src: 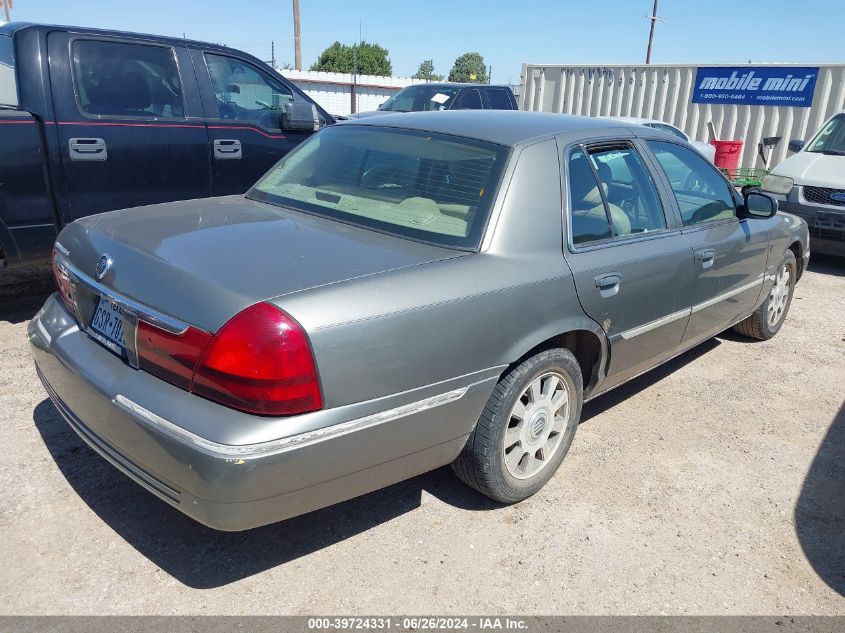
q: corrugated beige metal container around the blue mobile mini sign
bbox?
[520,64,845,167]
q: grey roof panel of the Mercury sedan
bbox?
[343,110,630,146]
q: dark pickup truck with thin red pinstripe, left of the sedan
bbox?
[0,23,334,265]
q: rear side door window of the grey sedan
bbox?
[569,143,666,244]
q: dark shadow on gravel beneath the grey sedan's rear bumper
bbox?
[33,400,501,589]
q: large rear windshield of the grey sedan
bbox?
[248,124,508,249]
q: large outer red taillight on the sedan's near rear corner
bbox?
[191,303,323,415]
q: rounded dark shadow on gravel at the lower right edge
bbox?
[795,403,845,596]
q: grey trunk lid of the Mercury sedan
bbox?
[59,196,465,332]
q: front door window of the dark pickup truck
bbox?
[205,53,293,130]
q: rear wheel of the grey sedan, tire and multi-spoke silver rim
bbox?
[452,349,584,503]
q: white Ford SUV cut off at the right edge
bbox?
[763,111,845,255]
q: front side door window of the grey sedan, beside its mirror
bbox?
[648,141,736,226]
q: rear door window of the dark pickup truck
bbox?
[72,40,184,118]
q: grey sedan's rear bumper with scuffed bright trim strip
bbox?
[28,295,499,531]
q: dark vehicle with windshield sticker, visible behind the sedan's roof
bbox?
[344,83,519,119]
